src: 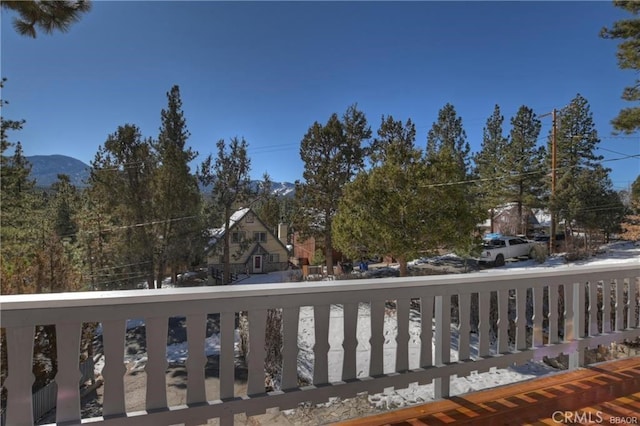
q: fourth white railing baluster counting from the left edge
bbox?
[144,317,168,411]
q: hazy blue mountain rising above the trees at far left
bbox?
[26,155,91,188]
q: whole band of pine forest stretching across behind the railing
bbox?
[0,79,638,294]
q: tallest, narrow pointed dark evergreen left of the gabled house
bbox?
[153,86,204,286]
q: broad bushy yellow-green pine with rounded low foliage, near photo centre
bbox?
[332,116,428,276]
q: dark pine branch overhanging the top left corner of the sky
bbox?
[0,0,91,38]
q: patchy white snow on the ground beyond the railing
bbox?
[96,243,640,409]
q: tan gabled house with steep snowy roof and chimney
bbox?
[207,208,289,275]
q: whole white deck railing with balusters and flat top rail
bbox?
[0,265,640,426]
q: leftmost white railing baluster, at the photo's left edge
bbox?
[4,326,34,426]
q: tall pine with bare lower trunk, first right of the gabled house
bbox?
[295,105,371,273]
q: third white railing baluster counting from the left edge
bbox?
[102,320,127,417]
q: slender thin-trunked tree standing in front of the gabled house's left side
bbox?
[198,137,255,284]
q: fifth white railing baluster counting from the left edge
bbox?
[185,314,207,404]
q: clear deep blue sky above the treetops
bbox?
[1,1,640,189]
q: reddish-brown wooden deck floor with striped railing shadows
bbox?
[341,356,640,426]
